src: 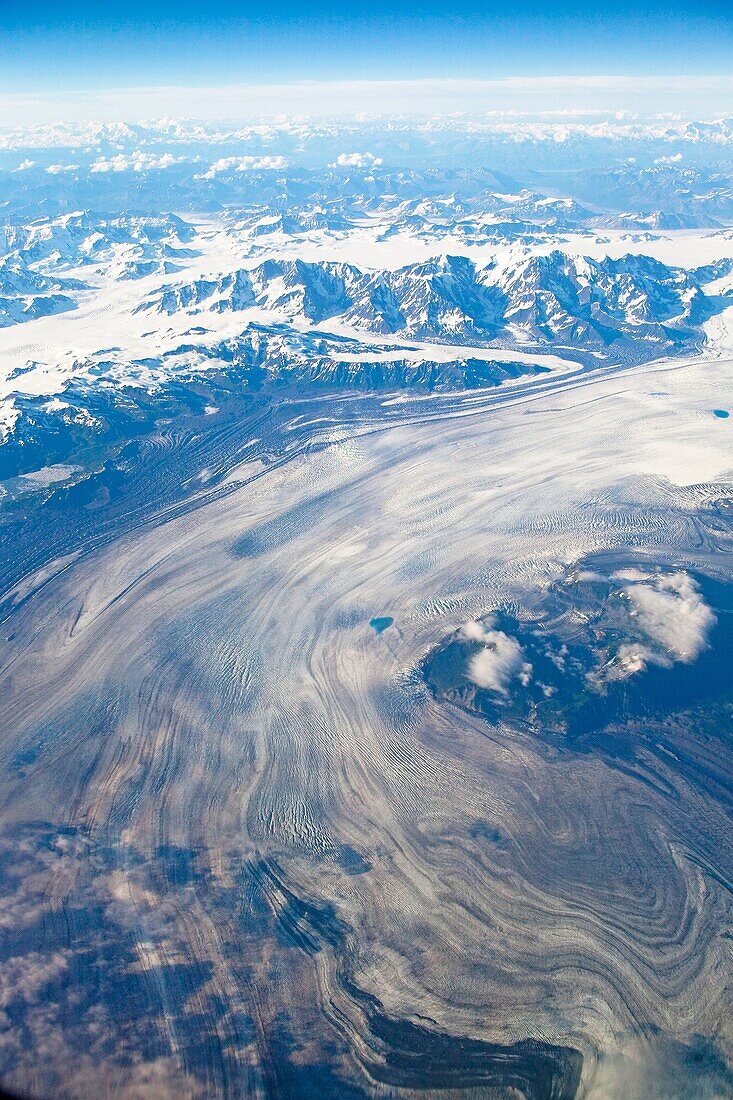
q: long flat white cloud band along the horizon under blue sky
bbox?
[0,75,733,127]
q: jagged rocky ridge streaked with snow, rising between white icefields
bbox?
[139,251,711,356]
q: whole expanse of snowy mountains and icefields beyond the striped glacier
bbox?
[0,144,733,493]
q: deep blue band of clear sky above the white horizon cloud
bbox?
[0,0,733,94]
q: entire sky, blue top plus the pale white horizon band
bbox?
[0,0,733,125]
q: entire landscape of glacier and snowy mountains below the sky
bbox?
[0,114,733,1100]
